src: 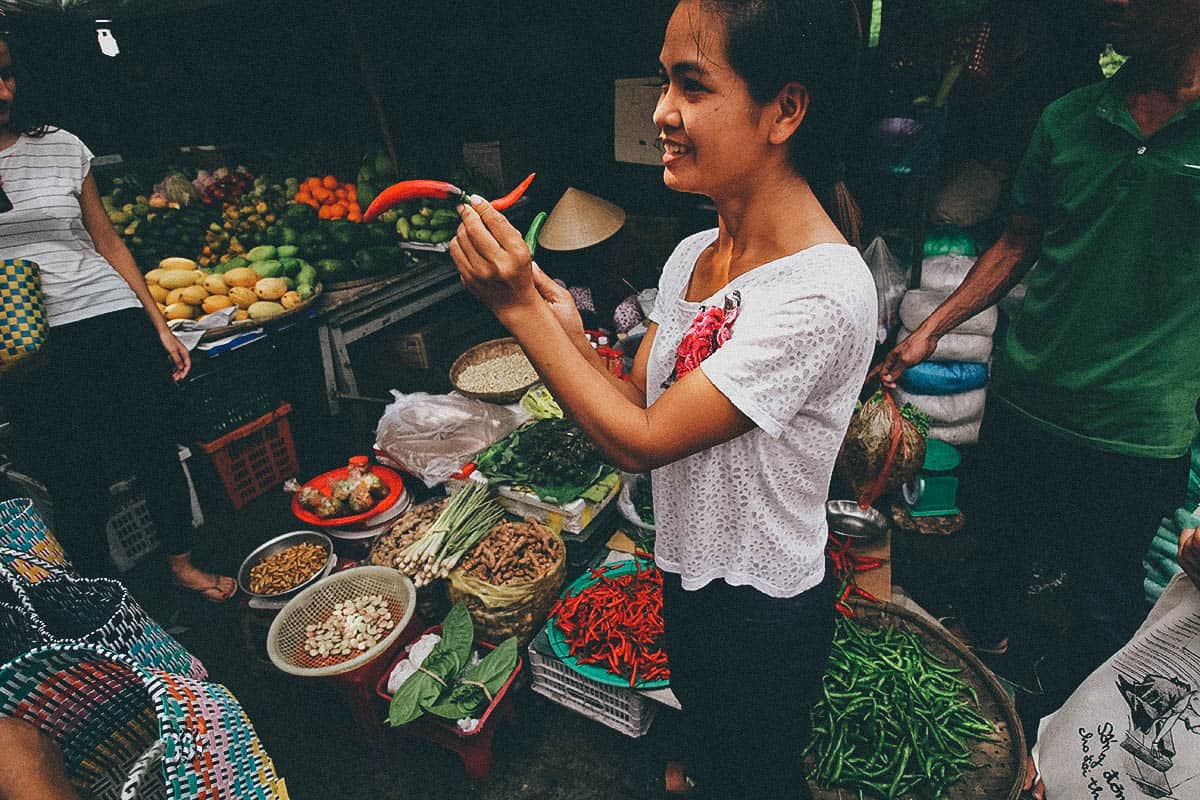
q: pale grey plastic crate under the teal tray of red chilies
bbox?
[527,648,659,738]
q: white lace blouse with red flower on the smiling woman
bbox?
[646,229,877,597]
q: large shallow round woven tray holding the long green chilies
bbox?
[810,600,1026,800]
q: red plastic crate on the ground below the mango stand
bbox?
[200,403,298,510]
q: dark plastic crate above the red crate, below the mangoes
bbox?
[182,365,278,441]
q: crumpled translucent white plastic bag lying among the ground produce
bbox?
[376,390,529,487]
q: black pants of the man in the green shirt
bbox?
[962,403,1189,708]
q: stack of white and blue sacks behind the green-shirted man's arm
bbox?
[896,225,998,445]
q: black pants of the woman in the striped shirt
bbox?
[0,308,191,575]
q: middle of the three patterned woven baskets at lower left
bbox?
[0,547,208,679]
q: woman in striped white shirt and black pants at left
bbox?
[0,38,236,602]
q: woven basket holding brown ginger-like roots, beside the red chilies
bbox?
[446,522,566,648]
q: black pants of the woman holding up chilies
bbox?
[662,572,834,800]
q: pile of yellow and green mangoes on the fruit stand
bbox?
[145,250,317,323]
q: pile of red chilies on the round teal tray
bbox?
[550,560,670,687]
